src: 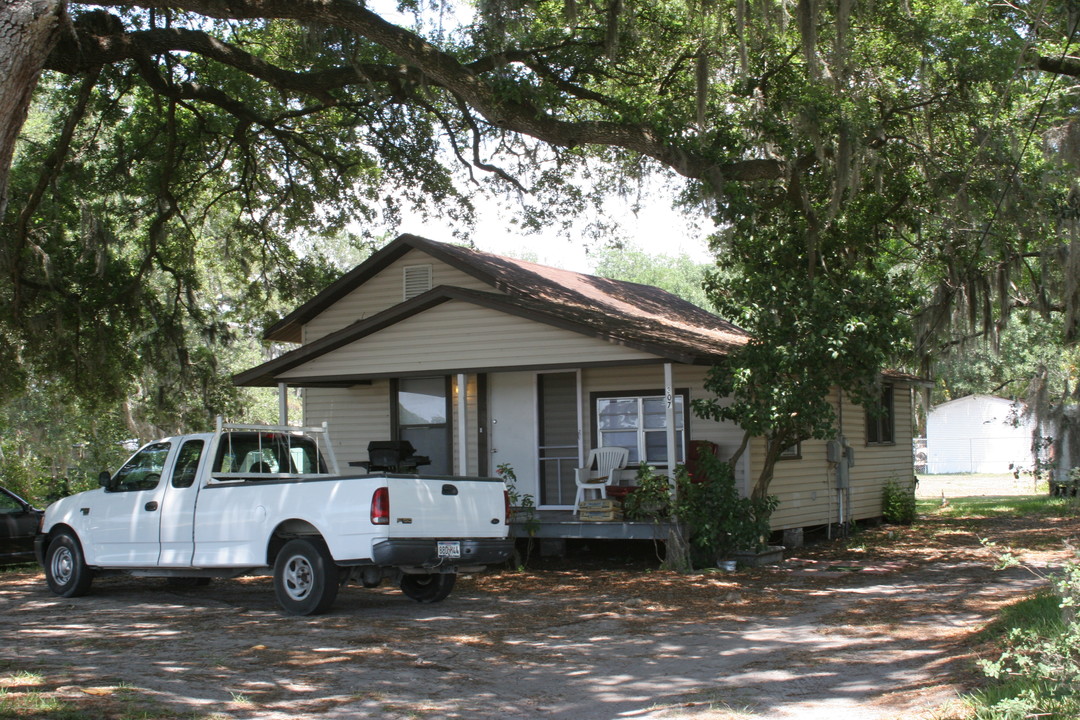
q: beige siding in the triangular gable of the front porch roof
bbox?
[279,301,656,380]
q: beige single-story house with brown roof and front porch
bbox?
[235,235,917,538]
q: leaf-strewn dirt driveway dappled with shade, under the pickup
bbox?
[0,492,1080,720]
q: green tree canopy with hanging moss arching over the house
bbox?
[6,0,1080,492]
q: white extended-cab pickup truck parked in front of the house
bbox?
[36,421,513,615]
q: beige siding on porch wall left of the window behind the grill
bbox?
[303,380,391,473]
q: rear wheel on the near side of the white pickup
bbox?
[273,538,339,615]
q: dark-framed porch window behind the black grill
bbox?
[393,377,450,475]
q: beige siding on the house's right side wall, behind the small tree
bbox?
[752,384,914,530]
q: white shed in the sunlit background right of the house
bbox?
[927,395,1035,474]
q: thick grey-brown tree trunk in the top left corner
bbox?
[0,0,64,217]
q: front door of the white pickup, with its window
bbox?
[86,440,175,568]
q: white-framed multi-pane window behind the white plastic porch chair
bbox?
[593,390,689,467]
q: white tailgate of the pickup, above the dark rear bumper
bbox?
[386,474,507,538]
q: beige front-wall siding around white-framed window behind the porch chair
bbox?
[582,363,745,485]
